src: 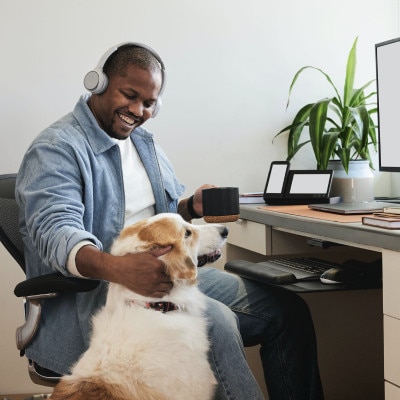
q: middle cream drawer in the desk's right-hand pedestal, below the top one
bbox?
[383,315,400,386]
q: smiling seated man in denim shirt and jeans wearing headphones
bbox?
[16,43,323,400]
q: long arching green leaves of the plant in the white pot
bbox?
[274,37,377,173]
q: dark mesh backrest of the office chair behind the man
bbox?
[0,174,25,272]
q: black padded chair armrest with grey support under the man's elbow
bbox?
[14,272,100,354]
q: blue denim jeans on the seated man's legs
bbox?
[198,267,324,400]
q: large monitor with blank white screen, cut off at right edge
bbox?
[375,38,400,172]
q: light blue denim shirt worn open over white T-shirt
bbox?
[16,96,184,374]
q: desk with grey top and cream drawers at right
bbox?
[226,205,400,400]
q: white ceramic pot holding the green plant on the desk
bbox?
[328,160,374,203]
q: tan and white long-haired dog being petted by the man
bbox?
[51,213,228,400]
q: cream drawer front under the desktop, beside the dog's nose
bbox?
[228,219,271,255]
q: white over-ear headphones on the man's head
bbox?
[83,42,165,118]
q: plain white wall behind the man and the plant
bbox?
[0,0,399,393]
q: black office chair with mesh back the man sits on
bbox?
[0,174,99,386]
